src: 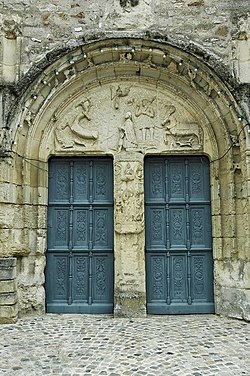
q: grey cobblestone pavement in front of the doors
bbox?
[0,314,250,376]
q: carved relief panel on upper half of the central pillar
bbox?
[115,161,143,234]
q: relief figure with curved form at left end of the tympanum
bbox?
[55,99,98,149]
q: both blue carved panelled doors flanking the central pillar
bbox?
[46,157,214,314]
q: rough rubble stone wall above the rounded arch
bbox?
[1,0,249,82]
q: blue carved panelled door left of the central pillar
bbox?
[46,158,113,313]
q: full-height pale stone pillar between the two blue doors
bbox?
[114,153,146,317]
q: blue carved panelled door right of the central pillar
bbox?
[145,157,214,314]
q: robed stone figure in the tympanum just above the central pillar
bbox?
[118,112,137,152]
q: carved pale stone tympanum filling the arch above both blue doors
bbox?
[52,82,204,155]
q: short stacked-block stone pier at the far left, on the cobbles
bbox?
[0,257,18,324]
